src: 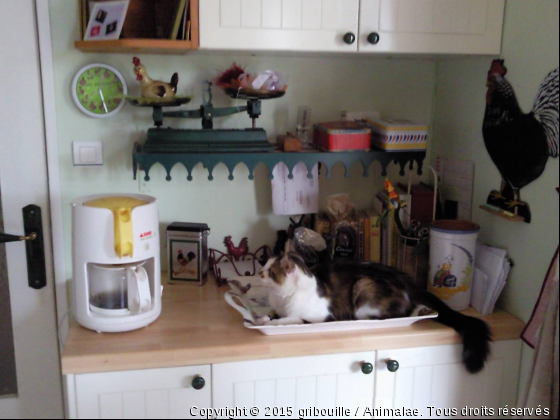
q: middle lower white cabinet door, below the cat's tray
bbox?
[212,352,375,418]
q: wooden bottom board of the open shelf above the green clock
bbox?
[75,39,198,55]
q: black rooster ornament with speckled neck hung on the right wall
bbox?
[483,60,559,223]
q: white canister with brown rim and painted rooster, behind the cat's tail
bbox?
[428,220,480,311]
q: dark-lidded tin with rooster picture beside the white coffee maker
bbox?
[167,222,210,286]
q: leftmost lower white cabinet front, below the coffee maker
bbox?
[74,366,212,419]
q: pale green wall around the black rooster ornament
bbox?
[432,0,559,400]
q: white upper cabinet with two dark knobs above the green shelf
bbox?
[199,0,505,54]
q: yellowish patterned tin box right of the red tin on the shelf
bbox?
[365,118,430,152]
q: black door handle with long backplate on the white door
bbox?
[0,204,47,290]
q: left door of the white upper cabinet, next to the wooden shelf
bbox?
[200,0,360,52]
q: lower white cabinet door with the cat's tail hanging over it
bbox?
[375,340,521,418]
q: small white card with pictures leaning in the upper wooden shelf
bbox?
[84,0,130,41]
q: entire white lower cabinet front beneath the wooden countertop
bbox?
[65,340,521,419]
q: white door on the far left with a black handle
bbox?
[0,0,63,418]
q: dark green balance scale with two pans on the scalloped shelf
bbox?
[129,81,286,153]
